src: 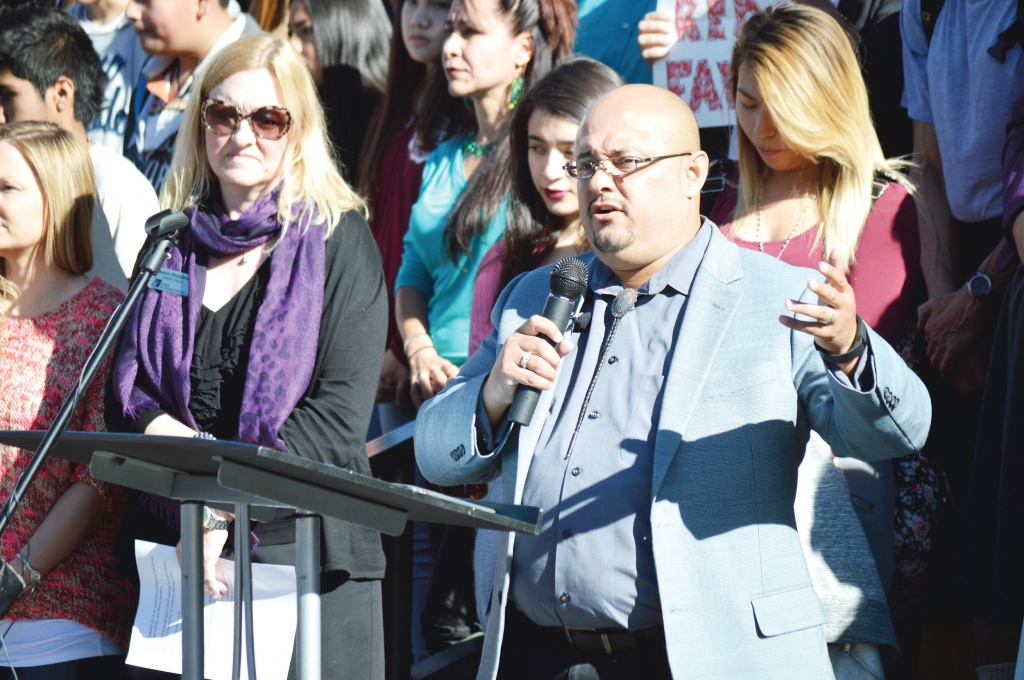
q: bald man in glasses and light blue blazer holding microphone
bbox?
[416,85,931,680]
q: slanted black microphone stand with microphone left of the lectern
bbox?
[0,210,188,618]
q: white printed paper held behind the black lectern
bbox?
[128,541,297,680]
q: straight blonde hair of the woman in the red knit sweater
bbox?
[0,123,96,299]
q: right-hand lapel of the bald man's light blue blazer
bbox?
[651,228,742,499]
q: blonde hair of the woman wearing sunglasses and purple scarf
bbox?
[161,36,367,240]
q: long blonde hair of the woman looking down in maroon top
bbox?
[730,2,911,267]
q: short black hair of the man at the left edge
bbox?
[0,6,106,126]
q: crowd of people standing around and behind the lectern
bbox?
[0,0,1024,680]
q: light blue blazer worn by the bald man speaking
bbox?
[416,227,931,680]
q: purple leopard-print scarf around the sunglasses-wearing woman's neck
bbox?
[114,185,327,452]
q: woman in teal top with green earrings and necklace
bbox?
[395,0,575,408]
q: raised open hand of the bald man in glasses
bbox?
[778,248,859,376]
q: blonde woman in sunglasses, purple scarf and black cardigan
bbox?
[108,36,387,679]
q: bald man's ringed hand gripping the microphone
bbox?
[481,315,572,427]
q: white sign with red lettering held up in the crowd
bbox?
[654,0,778,127]
